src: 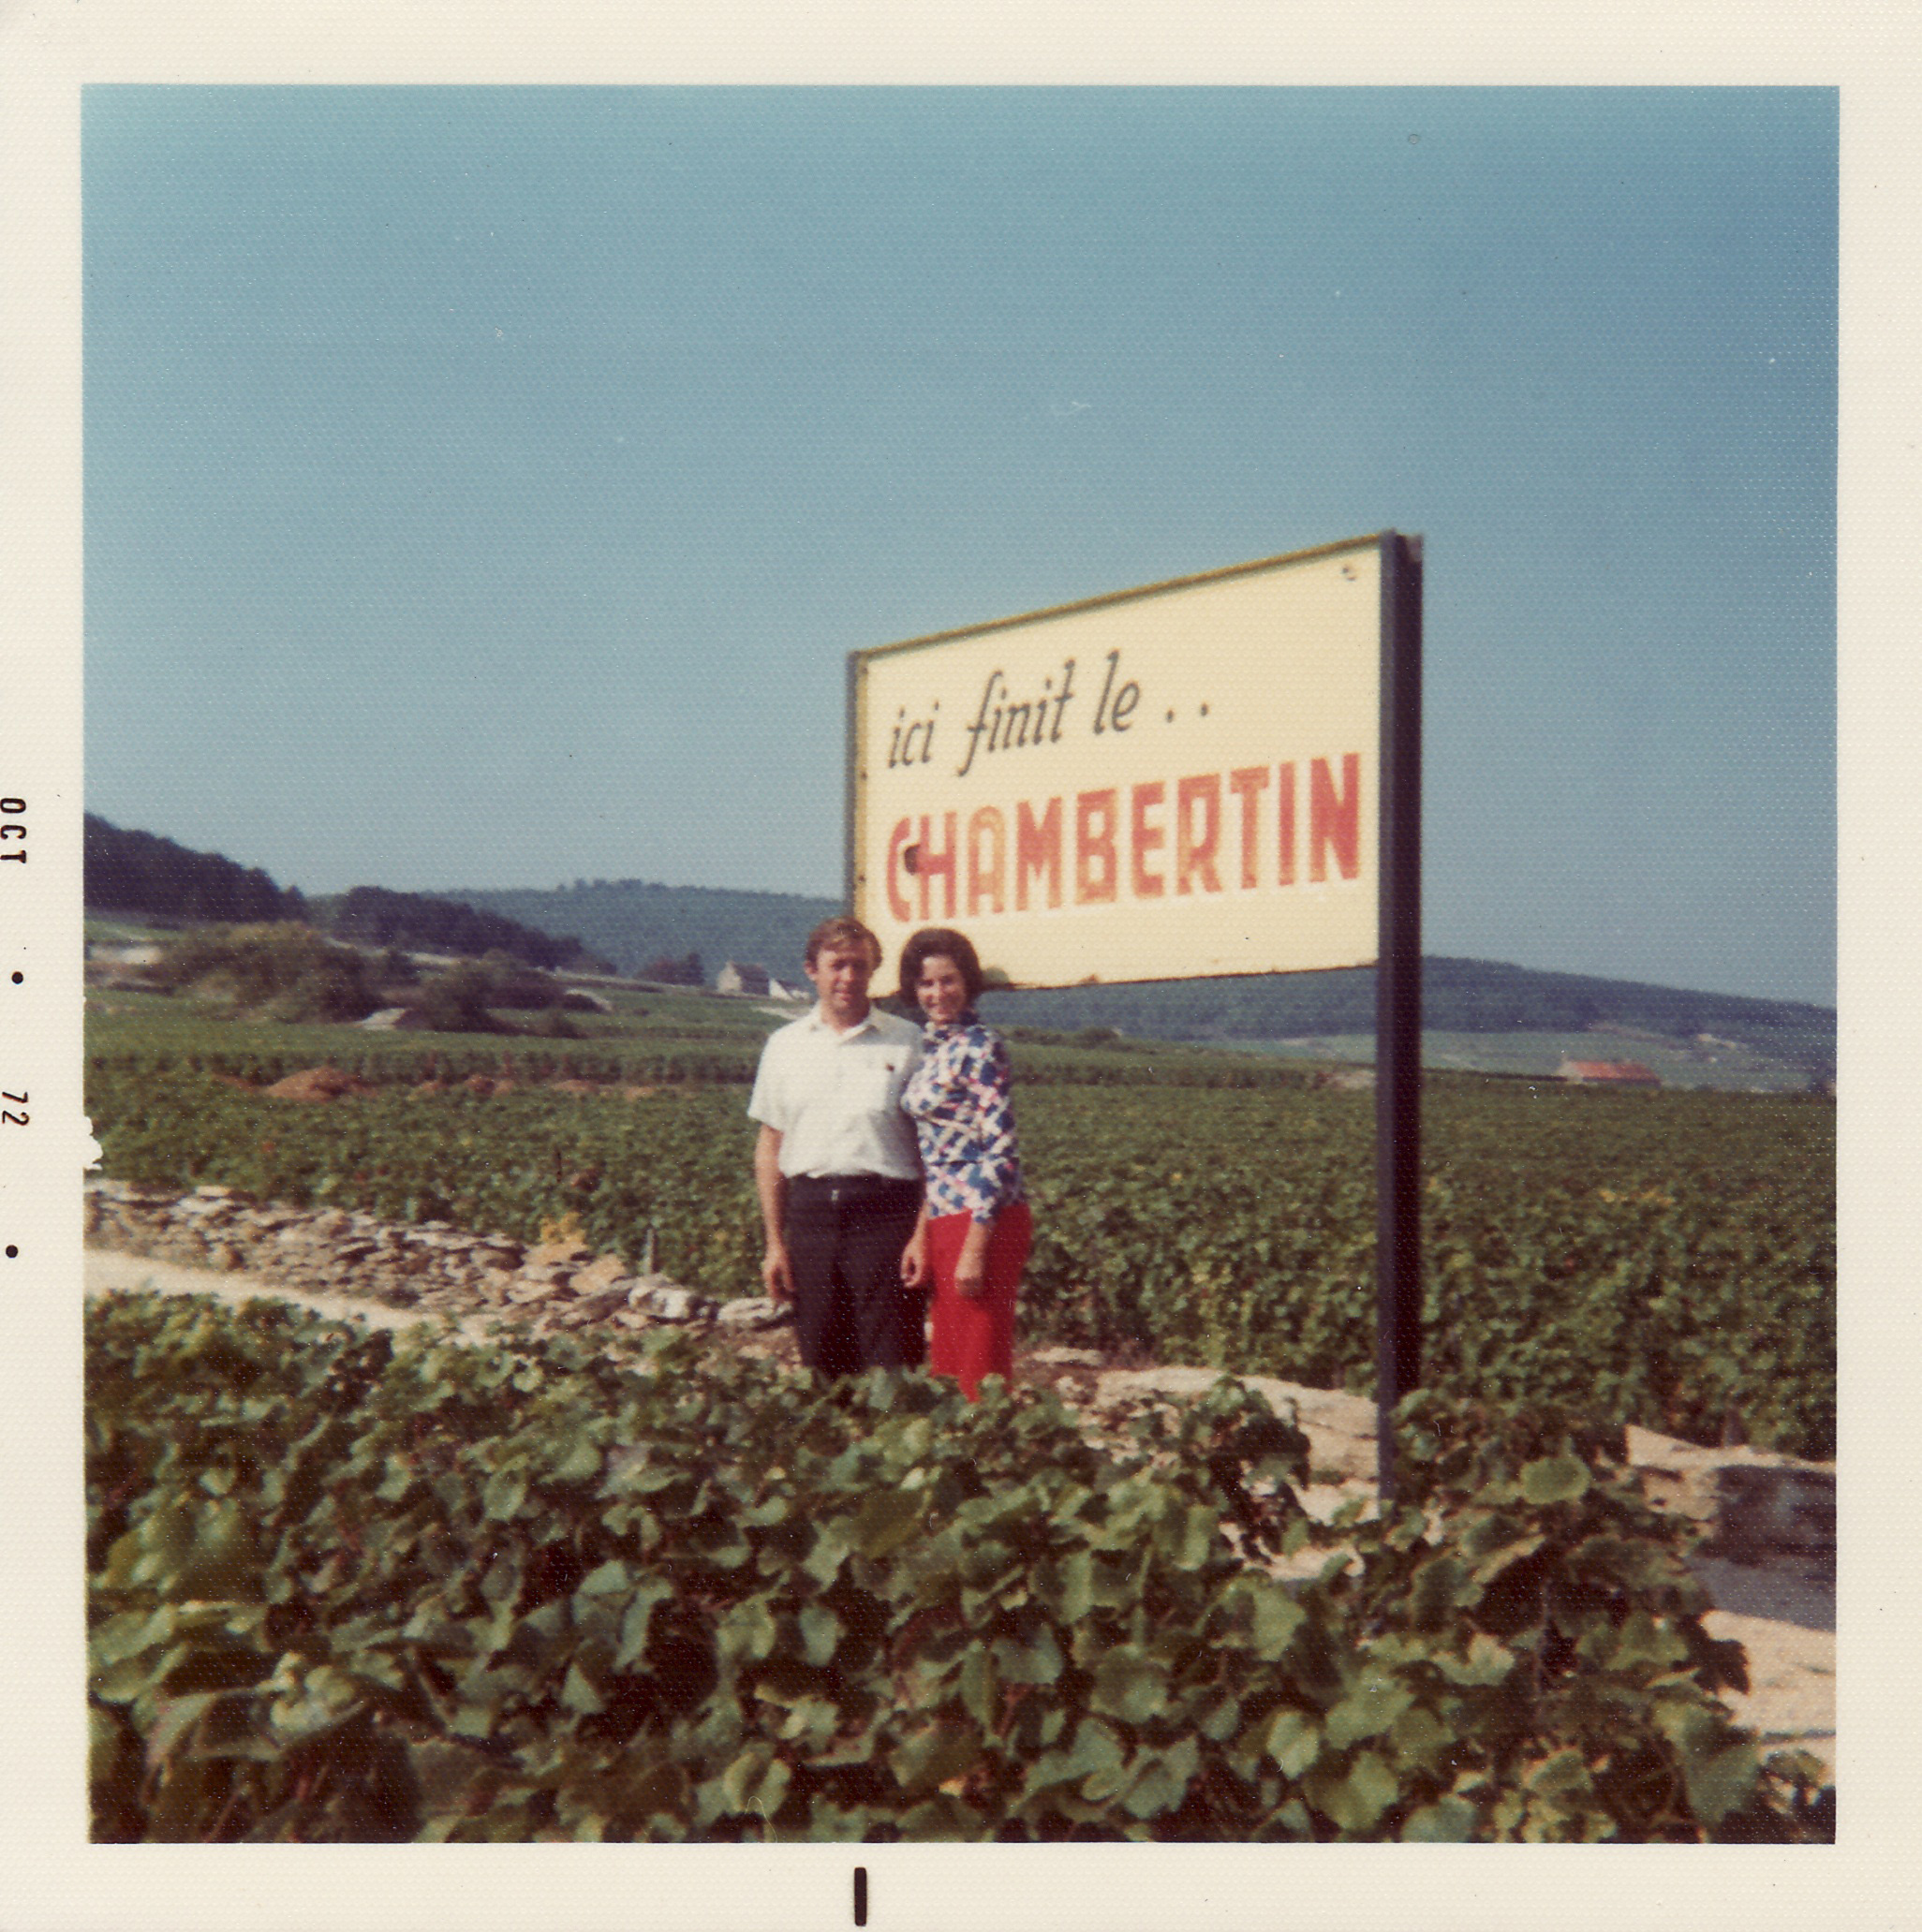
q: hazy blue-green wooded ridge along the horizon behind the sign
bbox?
[446,879,1835,1074]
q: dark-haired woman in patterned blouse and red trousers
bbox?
[900,925,1033,1403]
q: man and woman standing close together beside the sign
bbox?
[747,918,1031,1401]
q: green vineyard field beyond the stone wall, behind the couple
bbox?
[89,1020,1835,1457]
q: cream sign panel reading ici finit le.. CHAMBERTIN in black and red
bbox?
[848,538,1383,985]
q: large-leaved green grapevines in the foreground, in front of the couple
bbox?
[87,1294,1835,1843]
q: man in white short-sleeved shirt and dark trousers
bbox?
[747,918,927,1379]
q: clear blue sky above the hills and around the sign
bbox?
[83,87,1837,1001]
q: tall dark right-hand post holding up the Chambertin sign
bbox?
[1375,531,1422,1503]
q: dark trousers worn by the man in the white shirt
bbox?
[786,1174,927,1379]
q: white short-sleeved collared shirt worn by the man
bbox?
[747,1007,922,1180]
